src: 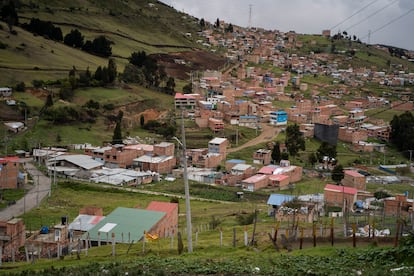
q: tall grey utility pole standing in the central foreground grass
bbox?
[177,110,193,253]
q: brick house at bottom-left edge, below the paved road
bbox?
[0,218,26,260]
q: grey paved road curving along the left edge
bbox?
[0,162,51,221]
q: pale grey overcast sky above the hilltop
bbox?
[162,0,414,50]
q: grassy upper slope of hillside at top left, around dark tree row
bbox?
[0,0,202,86]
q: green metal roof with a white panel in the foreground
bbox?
[83,207,166,243]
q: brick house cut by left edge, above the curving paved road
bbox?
[0,156,20,189]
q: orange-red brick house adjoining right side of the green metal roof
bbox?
[146,201,178,238]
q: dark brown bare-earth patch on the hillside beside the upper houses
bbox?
[151,50,226,80]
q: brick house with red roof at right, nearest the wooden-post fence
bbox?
[324,184,358,210]
